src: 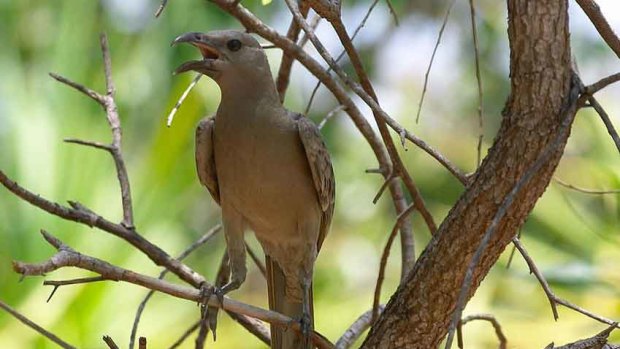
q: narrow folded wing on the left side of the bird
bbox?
[196,117,220,205]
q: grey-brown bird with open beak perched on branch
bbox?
[173,30,335,349]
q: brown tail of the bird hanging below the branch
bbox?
[265,256,314,349]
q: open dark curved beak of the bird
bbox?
[170,32,221,74]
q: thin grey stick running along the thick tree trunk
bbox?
[445,73,583,349]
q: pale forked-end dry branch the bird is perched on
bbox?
[13,231,333,348]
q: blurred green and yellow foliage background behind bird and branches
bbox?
[0,0,620,349]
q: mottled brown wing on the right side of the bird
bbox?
[293,114,336,249]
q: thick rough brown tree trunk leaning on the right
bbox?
[362,0,574,349]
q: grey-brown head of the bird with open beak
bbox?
[172,30,271,86]
